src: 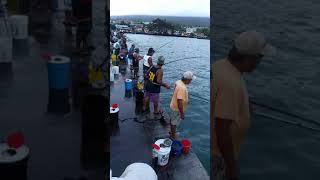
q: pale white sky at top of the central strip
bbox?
[110,0,210,17]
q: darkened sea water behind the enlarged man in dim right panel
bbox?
[211,0,320,180]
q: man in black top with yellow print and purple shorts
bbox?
[143,56,170,115]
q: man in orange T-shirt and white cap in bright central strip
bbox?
[170,71,196,139]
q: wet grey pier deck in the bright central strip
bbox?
[110,66,209,180]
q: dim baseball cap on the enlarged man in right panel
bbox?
[234,31,275,56]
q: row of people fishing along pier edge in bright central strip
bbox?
[111,32,195,139]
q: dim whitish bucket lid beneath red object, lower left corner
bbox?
[0,143,29,163]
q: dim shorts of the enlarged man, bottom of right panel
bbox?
[210,156,228,180]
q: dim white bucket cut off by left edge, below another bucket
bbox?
[0,36,12,63]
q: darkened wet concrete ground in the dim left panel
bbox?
[0,1,105,180]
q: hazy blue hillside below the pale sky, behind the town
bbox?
[111,15,210,27]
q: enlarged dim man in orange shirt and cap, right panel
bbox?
[210,31,273,180]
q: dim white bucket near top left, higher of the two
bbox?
[10,15,29,39]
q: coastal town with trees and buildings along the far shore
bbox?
[110,18,210,39]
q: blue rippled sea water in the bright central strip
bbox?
[126,34,210,171]
